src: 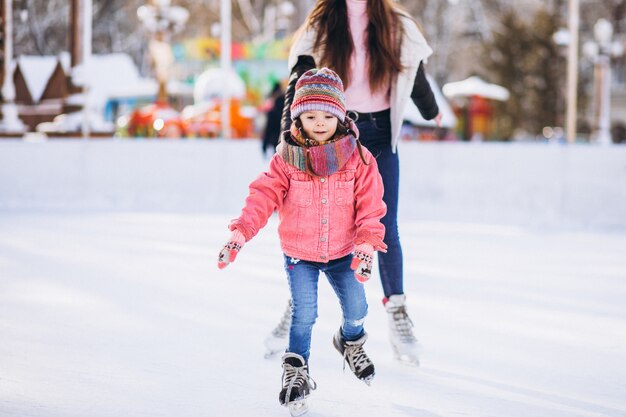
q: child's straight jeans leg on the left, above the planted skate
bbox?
[285,256,319,362]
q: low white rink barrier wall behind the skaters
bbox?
[0,139,626,232]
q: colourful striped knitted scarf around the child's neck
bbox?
[276,121,359,177]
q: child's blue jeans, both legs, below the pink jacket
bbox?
[285,254,367,361]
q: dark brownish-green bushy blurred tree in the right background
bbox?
[483,8,585,138]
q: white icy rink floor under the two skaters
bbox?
[0,211,626,417]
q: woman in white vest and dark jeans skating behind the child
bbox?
[266,0,441,365]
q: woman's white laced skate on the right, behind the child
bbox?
[383,294,420,366]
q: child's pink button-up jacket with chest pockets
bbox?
[229,148,387,262]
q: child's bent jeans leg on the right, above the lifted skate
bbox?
[323,255,367,341]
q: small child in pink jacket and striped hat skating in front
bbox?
[218,68,387,412]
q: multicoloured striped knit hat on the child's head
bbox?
[291,68,346,122]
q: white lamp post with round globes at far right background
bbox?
[583,19,624,145]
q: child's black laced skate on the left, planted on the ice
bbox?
[278,352,317,416]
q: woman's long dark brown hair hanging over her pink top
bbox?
[305,0,403,91]
